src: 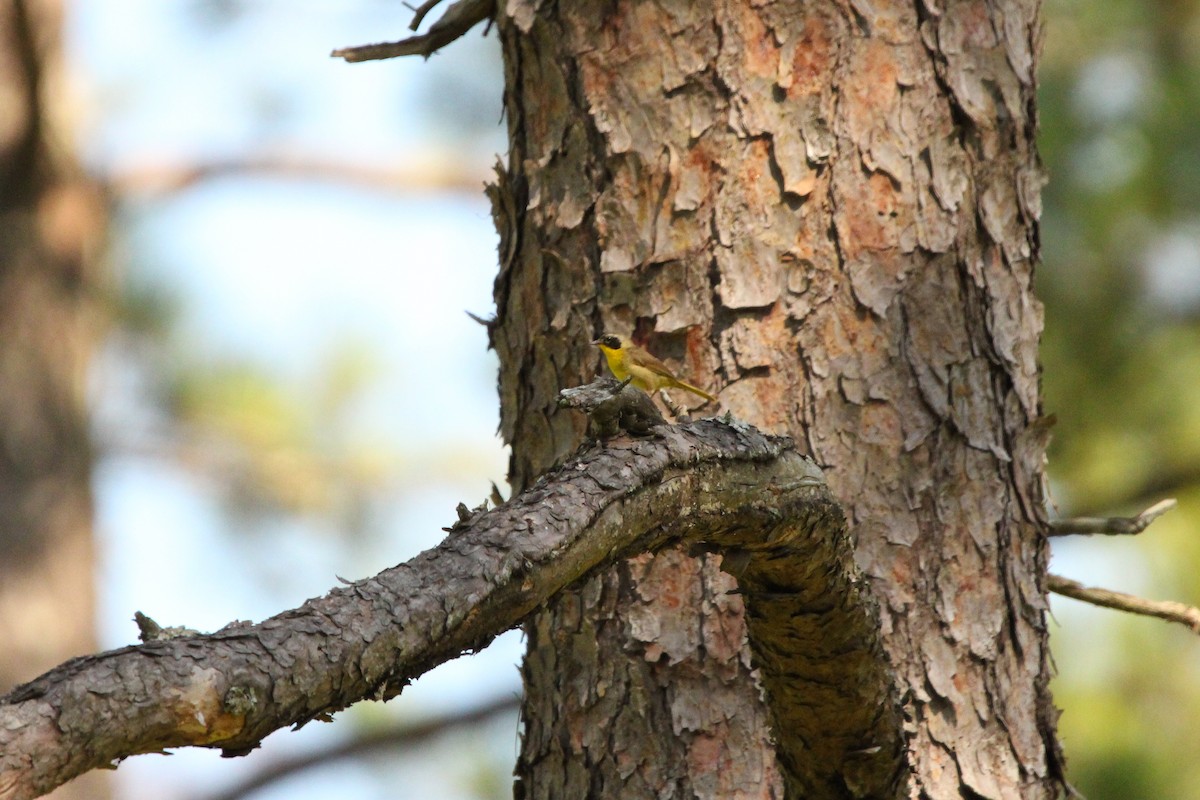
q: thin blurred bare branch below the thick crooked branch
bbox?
[199,697,521,800]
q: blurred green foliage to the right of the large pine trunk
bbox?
[1038,0,1200,800]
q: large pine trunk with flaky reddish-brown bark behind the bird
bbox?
[492,0,1061,799]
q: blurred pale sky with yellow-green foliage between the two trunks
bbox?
[63,0,521,800]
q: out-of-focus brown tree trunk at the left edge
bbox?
[0,0,107,798]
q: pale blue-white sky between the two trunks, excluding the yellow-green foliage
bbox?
[67,0,521,800]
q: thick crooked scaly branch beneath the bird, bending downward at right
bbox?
[0,412,902,800]
